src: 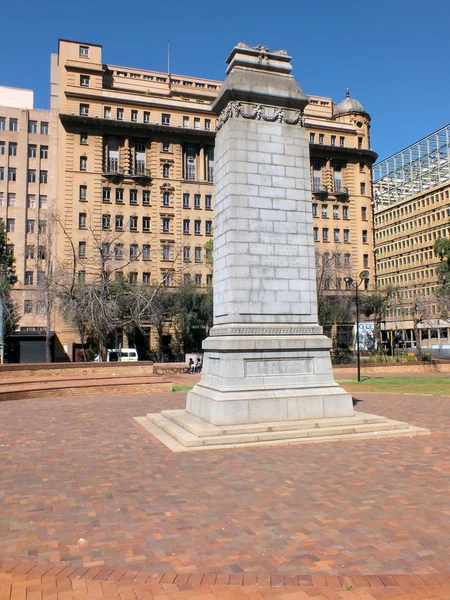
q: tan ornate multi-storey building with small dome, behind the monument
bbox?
[6,40,376,358]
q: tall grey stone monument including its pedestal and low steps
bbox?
[138,43,428,450]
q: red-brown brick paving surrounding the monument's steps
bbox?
[0,386,450,600]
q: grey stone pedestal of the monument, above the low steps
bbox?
[186,325,354,425]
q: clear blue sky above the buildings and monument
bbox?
[0,0,450,158]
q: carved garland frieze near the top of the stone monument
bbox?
[216,101,304,131]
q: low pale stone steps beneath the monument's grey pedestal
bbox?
[141,410,430,452]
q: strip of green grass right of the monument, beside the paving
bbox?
[338,375,450,396]
